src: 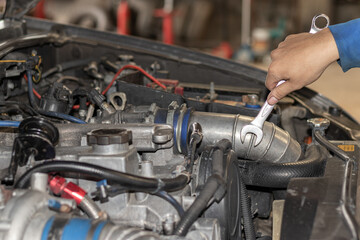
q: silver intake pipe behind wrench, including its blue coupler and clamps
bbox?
[155,105,301,163]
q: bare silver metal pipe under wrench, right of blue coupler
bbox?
[190,112,301,163]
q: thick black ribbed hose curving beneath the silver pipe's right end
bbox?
[239,145,327,188]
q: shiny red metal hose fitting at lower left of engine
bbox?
[49,176,86,204]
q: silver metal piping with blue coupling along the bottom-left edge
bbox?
[0,190,220,240]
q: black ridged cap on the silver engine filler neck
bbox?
[87,129,132,145]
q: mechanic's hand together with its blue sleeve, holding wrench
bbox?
[266,19,360,105]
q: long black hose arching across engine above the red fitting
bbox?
[15,161,189,193]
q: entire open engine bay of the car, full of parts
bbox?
[0,11,359,240]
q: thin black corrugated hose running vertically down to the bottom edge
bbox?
[239,172,256,240]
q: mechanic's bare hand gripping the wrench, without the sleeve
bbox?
[265,29,339,105]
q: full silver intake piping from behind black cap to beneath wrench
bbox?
[56,105,301,163]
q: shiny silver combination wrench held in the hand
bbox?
[240,14,329,146]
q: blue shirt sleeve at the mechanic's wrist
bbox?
[329,18,360,72]
